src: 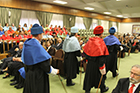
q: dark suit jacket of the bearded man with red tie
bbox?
[112,78,140,93]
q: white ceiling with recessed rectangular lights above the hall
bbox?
[33,0,140,18]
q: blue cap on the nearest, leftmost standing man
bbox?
[31,24,44,35]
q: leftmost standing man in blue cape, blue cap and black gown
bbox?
[22,24,59,93]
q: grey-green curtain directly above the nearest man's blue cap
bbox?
[36,11,53,26]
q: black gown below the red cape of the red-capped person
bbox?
[83,55,106,91]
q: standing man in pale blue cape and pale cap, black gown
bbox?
[63,27,81,86]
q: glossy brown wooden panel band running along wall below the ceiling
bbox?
[0,0,130,22]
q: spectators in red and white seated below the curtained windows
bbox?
[0,23,68,35]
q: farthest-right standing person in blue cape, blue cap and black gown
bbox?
[104,27,122,77]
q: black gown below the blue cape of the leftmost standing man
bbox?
[23,59,50,93]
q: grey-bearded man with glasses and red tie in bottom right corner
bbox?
[112,65,140,93]
